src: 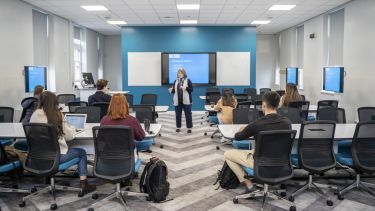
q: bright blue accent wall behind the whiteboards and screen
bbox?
[122,26,256,110]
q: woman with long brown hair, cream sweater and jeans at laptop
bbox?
[30,91,96,194]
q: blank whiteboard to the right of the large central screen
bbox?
[216,52,250,86]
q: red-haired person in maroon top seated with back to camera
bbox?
[100,94,153,157]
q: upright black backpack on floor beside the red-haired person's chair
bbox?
[139,158,169,202]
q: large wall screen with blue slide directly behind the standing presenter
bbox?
[161,53,216,85]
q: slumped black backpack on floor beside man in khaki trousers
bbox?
[214,162,240,189]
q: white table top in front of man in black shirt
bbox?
[218,124,356,140]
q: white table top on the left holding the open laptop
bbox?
[0,123,161,139]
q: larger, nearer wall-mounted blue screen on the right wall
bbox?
[323,67,344,93]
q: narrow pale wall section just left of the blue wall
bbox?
[103,35,122,90]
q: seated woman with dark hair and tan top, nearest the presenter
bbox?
[214,92,237,124]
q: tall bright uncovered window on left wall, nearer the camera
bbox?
[73,26,82,81]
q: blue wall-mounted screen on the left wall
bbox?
[25,66,47,92]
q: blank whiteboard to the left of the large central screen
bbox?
[128,52,161,86]
